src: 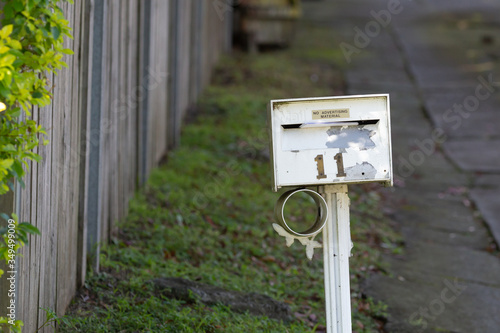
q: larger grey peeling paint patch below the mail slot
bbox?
[326,127,375,150]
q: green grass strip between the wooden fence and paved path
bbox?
[59,22,399,333]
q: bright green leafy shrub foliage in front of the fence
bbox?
[0,0,73,332]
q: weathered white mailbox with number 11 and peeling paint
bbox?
[268,94,393,191]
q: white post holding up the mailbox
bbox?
[320,185,352,333]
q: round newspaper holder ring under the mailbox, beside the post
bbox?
[274,188,328,237]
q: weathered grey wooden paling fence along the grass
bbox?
[0,0,232,332]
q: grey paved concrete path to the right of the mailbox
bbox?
[304,0,500,333]
